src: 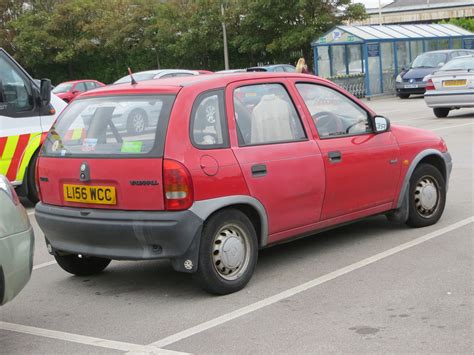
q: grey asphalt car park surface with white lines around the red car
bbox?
[0,97,474,354]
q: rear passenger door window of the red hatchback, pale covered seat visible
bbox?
[234,84,306,146]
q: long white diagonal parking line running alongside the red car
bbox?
[150,216,474,348]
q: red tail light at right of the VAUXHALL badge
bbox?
[163,159,194,211]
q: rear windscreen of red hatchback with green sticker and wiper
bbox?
[42,95,176,157]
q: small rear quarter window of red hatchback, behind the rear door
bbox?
[190,90,229,149]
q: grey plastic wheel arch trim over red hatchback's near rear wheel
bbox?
[191,195,268,248]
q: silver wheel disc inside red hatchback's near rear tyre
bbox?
[212,224,250,280]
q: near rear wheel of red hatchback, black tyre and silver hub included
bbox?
[195,209,258,295]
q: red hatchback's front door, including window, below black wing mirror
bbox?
[296,83,401,220]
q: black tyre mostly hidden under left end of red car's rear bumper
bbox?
[54,254,111,276]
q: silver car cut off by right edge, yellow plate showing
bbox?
[424,55,474,117]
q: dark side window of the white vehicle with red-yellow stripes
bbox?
[0,57,34,114]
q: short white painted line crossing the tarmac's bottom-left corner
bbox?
[0,321,187,355]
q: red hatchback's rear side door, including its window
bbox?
[226,79,325,243]
